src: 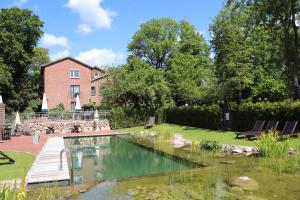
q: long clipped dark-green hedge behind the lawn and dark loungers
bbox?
[166,100,300,131]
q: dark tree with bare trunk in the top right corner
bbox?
[244,0,300,99]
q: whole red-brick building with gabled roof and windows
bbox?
[42,57,108,111]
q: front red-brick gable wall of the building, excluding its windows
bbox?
[44,59,92,110]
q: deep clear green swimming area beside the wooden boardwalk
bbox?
[65,136,191,184]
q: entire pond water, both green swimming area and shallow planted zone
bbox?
[65,137,300,200]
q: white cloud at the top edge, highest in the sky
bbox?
[64,0,116,33]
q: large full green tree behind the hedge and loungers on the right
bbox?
[210,1,289,101]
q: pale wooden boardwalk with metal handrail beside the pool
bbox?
[26,137,70,185]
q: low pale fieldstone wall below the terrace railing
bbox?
[30,120,110,133]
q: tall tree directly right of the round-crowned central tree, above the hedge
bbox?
[166,21,214,105]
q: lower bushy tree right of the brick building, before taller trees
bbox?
[102,57,169,113]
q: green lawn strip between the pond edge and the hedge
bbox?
[122,124,300,147]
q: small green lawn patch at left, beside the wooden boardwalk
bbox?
[0,151,35,181]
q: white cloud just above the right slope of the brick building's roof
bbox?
[76,48,125,67]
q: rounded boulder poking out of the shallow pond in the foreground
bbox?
[229,176,259,191]
